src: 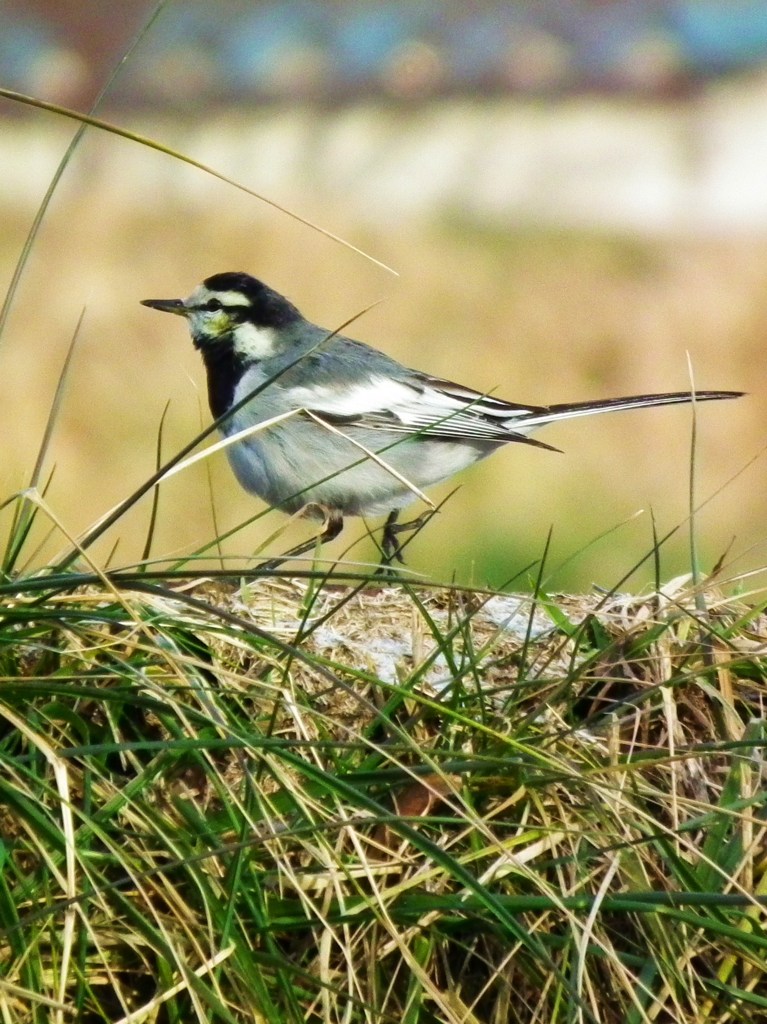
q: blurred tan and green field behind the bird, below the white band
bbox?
[0,115,767,587]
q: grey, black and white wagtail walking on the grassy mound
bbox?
[143,273,742,562]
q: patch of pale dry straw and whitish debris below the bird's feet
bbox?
[231,580,581,696]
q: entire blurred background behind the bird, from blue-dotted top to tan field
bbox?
[0,0,767,589]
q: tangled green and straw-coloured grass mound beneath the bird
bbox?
[0,570,767,1024]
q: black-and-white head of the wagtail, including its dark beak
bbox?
[141,272,302,362]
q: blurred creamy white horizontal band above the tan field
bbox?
[0,76,767,234]
